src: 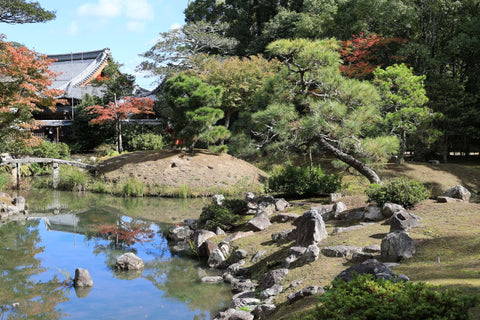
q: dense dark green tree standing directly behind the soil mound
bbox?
[162,74,226,151]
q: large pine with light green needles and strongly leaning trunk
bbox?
[267,39,400,183]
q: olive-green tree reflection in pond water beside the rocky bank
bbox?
[143,257,231,320]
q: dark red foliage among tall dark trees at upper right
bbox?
[340,33,406,79]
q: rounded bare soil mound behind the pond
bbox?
[96,150,267,194]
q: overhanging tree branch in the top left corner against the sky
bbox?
[0,0,55,24]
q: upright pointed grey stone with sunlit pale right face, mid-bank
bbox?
[295,210,328,247]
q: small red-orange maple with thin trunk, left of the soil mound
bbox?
[87,97,155,152]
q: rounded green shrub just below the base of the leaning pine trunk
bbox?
[365,178,430,209]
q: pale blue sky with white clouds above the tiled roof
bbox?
[0,0,188,89]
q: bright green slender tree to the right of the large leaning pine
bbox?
[374,64,438,158]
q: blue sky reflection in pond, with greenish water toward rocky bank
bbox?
[0,191,231,320]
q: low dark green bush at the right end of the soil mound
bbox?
[268,165,342,196]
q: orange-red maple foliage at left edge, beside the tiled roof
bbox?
[0,34,65,145]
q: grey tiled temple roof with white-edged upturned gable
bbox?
[48,48,111,99]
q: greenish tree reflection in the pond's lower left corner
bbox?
[0,220,68,320]
